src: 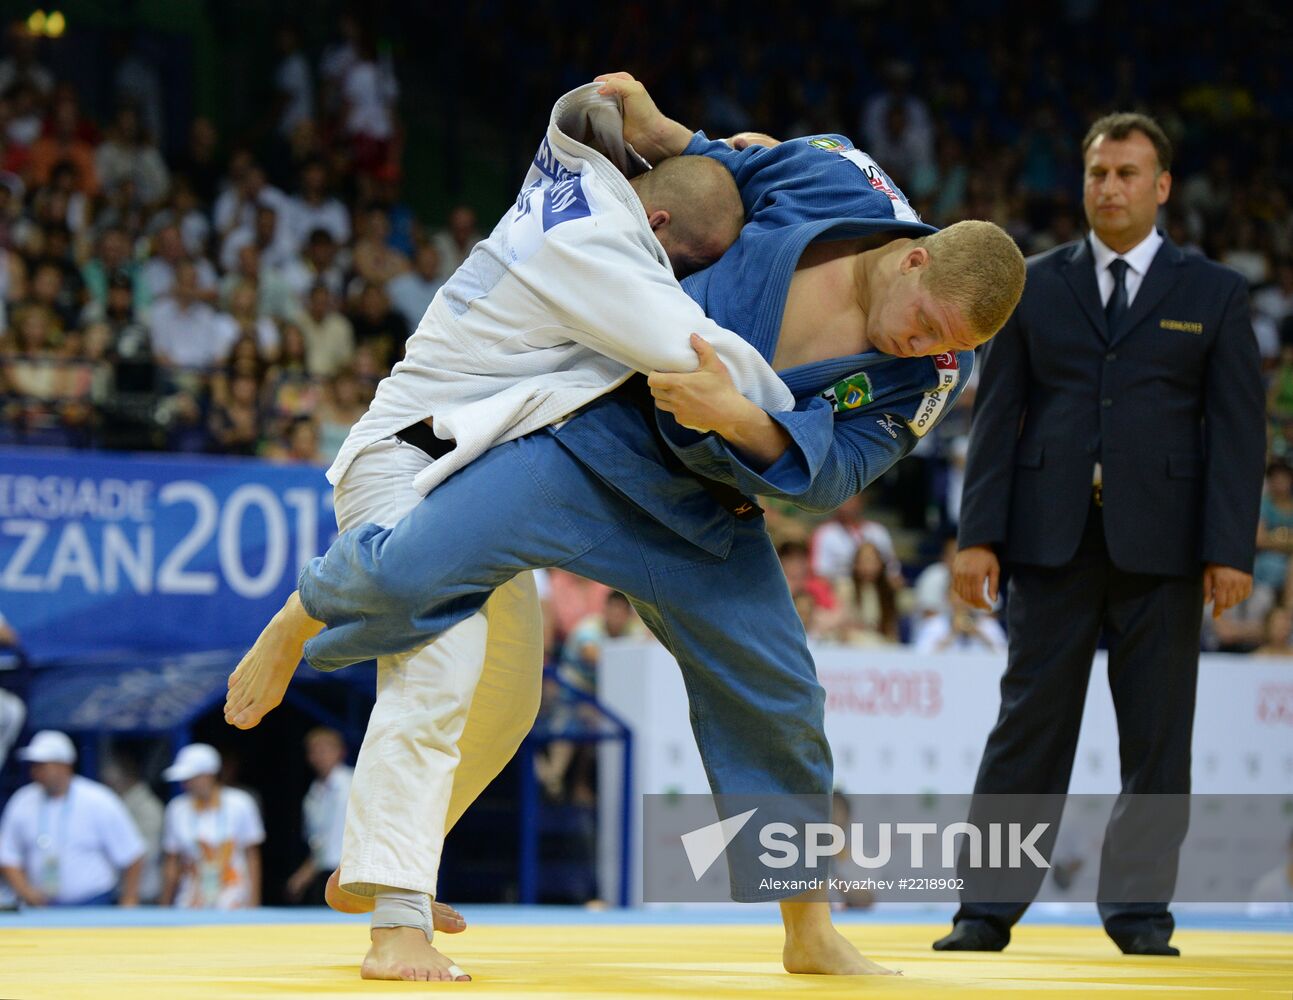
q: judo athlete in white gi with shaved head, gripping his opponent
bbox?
[226,84,794,978]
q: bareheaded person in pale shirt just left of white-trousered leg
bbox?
[286,727,354,906]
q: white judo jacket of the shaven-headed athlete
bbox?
[327,84,794,494]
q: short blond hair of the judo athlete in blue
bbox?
[915,219,1025,344]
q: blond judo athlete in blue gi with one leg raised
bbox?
[226,76,1024,973]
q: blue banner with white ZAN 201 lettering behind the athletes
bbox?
[0,449,336,661]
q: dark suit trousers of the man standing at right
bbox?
[956,503,1202,940]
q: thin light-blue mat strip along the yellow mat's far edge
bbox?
[0,903,1293,934]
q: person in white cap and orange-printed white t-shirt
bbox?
[162,743,265,909]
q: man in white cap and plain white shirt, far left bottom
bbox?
[0,730,144,906]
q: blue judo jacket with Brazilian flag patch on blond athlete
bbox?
[551,132,974,556]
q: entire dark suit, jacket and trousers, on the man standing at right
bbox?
[957,230,1266,940]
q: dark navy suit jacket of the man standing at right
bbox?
[958,231,1266,576]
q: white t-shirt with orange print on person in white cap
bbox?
[162,788,265,909]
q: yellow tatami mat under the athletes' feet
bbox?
[0,924,1293,1000]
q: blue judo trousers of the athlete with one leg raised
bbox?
[299,432,833,902]
